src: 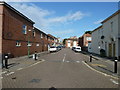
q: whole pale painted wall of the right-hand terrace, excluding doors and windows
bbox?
[91,11,120,57]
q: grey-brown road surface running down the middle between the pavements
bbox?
[2,49,118,88]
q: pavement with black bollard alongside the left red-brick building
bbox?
[1,51,49,74]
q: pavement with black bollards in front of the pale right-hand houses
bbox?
[80,52,120,79]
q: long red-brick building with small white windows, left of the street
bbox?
[0,2,53,57]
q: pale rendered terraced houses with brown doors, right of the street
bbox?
[92,10,120,57]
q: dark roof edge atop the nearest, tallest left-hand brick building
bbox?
[0,1,35,24]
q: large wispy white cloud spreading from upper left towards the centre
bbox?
[9,3,86,35]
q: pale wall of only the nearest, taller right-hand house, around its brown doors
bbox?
[103,15,119,56]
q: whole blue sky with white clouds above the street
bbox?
[8,2,118,39]
